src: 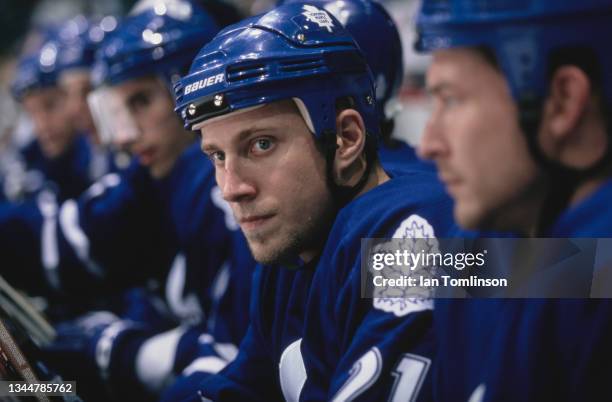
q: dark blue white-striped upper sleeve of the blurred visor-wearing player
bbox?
[55,160,176,286]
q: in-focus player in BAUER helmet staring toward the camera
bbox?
[167,4,460,401]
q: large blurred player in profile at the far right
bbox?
[416,0,612,402]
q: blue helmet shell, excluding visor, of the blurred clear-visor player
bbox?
[95,1,219,85]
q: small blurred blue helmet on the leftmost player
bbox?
[11,39,58,100]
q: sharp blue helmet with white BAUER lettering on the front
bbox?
[175,4,379,137]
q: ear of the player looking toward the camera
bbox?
[333,109,366,187]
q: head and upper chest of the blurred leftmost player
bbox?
[5,40,97,201]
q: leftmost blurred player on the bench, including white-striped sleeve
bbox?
[0,30,123,286]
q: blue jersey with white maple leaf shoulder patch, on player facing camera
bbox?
[196,172,455,402]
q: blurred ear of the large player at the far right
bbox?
[539,65,607,168]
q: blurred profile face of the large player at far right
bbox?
[419,49,537,229]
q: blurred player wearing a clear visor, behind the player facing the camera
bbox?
[2,2,253,400]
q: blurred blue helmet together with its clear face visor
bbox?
[87,0,219,143]
